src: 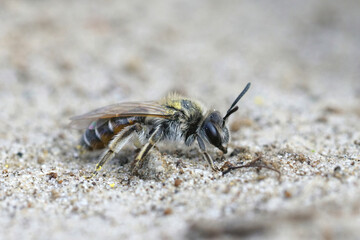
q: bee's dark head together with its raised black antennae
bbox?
[201,83,250,153]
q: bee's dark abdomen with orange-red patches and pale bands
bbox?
[81,117,140,150]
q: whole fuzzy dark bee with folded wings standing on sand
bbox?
[70,83,250,176]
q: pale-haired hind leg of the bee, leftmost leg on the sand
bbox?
[89,123,143,178]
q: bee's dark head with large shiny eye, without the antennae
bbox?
[200,111,229,153]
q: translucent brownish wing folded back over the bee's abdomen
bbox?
[69,101,171,129]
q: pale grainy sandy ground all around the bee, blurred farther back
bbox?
[0,0,360,239]
